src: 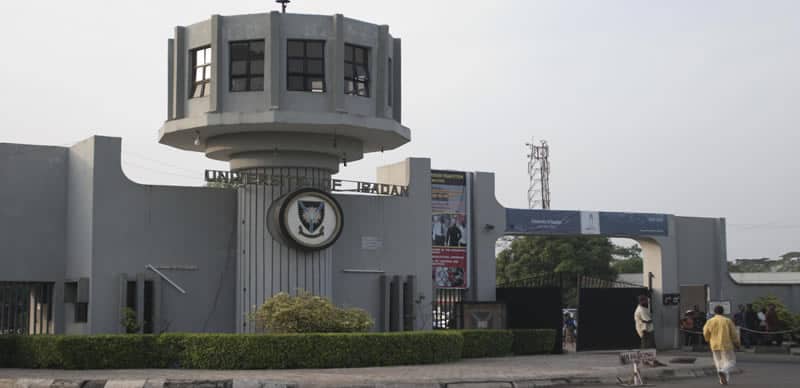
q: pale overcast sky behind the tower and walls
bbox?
[0,0,800,259]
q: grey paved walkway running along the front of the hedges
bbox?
[0,353,713,387]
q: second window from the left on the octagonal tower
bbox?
[230,40,264,92]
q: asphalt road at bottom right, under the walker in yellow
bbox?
[592,360,800,388]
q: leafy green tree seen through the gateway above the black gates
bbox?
[497,236,617,284]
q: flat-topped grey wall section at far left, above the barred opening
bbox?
[0,143,68,332]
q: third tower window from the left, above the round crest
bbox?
[286,39,325,93]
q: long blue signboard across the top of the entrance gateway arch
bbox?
[506,209,669,236]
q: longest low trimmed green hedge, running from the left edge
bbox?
[0,331,464,369]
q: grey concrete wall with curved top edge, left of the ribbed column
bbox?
[90,137,236,333]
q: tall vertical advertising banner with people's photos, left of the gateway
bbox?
[431,170,470,288]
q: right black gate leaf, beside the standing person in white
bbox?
[576,276,649,351]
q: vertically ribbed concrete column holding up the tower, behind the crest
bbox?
[236,167,332,333]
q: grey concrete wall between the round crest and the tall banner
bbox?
[333,159,433,329]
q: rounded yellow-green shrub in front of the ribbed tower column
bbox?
[251,290,374,333]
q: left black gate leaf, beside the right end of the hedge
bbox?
[496,274,565,353]
